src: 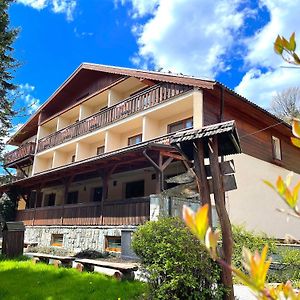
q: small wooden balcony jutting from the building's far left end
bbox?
[4,142,36,168]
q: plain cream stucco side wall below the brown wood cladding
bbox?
[226,154,300,239]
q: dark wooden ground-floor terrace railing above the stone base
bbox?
[16,197,150,226]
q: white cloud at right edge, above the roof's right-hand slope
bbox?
[235,0,300,107]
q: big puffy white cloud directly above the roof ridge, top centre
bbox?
[123,0,249,77]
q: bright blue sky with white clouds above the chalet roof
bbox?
[10,0,300,129]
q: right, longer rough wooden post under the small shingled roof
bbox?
[209,136,234,300]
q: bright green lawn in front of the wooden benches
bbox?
[0,260,146,300]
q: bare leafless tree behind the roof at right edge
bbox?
[271,87,300,123]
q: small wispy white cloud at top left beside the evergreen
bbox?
[16,0,76,21]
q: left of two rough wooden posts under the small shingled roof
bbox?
[193,139,212,227]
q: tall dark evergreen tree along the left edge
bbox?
[0,0,18,157]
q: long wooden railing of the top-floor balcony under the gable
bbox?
[37,83,191,152]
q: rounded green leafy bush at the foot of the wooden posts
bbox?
[132,218,224,299]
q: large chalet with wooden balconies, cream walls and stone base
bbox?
[1,63,300,251]
